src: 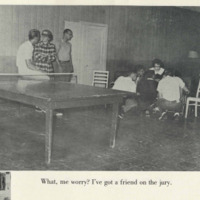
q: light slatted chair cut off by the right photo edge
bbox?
[185,80,200,118]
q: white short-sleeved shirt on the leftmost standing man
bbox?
[16,41,34,74]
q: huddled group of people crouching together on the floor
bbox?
[113,59,189,120]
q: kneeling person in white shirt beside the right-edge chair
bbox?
[157,69,189,119]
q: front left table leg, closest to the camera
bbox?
[45,110,53,164]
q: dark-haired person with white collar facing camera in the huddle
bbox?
[149,59,165,82]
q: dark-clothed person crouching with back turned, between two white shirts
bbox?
[137,70,157,110]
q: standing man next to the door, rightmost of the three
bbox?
[56,29,74,82]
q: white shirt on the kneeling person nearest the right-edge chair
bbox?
[157,76,185,102]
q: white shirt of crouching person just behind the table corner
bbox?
[112,76,136,93]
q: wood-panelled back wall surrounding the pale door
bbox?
[0,6,200,79]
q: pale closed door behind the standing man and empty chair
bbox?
[65,22,108,85]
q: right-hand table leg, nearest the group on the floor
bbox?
[110,103,119,148]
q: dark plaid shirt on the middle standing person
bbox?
[33,42,56,73]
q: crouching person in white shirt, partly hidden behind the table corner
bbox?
[112,70,137,115]
